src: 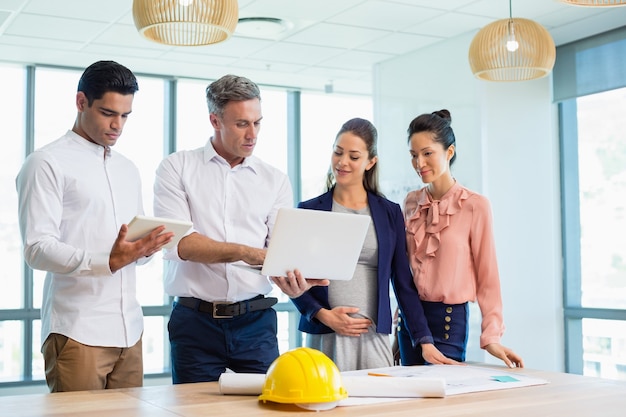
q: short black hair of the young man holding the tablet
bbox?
[78,61,139,106]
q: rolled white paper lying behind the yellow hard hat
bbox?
[219,373,445,398]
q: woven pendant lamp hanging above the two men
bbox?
[133,0,239,46]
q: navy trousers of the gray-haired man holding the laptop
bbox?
[167,302,278,384]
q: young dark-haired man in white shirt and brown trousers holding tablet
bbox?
[16,61,172,392]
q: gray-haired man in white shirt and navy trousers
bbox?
[154,75,327,384]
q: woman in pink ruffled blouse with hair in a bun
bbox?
[398,110,524,367]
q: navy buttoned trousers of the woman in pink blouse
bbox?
[398,301,469,365]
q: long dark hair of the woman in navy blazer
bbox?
[326,117,383,196]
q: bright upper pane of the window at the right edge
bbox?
[577,88,626,312]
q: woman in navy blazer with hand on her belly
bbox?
[292,118,456,371]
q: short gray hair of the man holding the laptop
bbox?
[206,74,261,117]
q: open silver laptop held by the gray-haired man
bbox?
[235,208,371,280]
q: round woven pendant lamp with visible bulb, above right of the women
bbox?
[469,1,556,81]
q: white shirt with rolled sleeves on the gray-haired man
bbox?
[154,140,293,302]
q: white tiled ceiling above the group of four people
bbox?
[0,0,626,94]
